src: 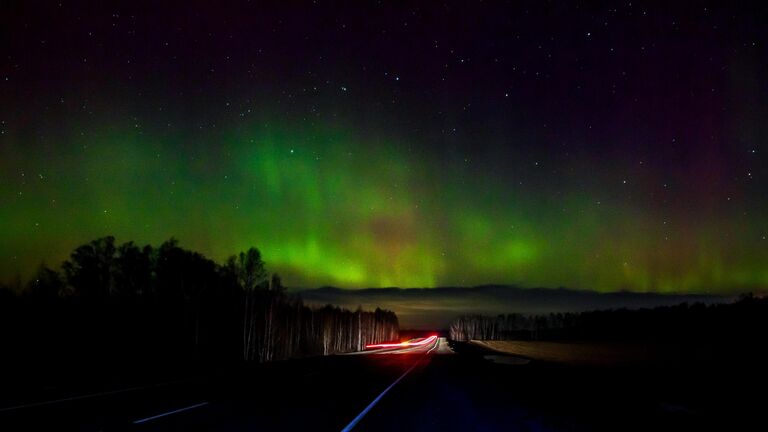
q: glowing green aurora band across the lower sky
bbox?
[0,121,768,292]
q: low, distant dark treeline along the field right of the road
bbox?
[450,294,768,343]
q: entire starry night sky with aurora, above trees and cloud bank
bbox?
[0,0,768,294]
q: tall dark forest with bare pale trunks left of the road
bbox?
[0,237,398,365]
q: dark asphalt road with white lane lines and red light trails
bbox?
[0,338,752,431]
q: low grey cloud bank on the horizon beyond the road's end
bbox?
[294,285,733,329]
